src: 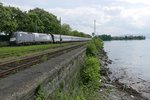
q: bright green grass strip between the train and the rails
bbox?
[0,43,81,61]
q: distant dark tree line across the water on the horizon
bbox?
[97,34,145,41]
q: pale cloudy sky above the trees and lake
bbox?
[0,0,150,36]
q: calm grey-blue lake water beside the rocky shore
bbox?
[104,39,150,98]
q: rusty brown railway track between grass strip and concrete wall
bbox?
[0,43,85,78]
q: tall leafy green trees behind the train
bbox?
[0,3,91,37]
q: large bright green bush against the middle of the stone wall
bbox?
[82,57,100,89]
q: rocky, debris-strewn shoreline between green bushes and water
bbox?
[99,50,149,100]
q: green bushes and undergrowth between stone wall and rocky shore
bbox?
[51,39,103,100]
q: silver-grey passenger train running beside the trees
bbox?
[10,32,91,45]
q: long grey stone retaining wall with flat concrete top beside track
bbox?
[0,47,85,100]
